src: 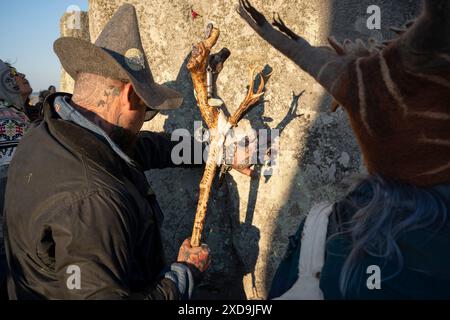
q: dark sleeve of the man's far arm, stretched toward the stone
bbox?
[133,130,204,171]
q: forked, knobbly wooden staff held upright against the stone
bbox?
[187,27,270,247]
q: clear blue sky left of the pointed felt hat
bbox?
[0,0,88,92]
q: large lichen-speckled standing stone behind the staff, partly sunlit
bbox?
[61,0,418,299]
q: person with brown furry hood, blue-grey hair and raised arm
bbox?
[239,0,450,299]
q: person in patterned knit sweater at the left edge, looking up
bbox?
[0,60,32,299]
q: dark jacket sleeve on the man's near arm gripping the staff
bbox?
[52,192,179,299]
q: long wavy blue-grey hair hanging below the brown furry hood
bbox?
[330,176,450,297]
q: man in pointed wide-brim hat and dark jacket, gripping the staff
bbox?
[5,5,215,299]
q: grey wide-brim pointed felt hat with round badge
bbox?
[53,4,183,120]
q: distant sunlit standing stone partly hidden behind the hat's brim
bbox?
[59,7,91,93]
